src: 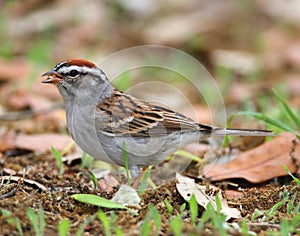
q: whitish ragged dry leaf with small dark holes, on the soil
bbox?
[176,174,241,220]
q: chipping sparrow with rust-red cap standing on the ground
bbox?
[42,59,273,184]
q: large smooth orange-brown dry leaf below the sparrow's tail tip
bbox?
[203,132,300,183]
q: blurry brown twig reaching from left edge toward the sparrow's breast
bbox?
[0,102,64,121]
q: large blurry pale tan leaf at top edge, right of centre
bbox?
[142,1,237,44]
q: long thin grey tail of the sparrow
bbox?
[212,128,276,136]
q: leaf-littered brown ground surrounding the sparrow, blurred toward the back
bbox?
[0,0,300,235]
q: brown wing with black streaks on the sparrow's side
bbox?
[96,90,211,136]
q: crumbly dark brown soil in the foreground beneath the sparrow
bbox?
[0,150,300,235]
